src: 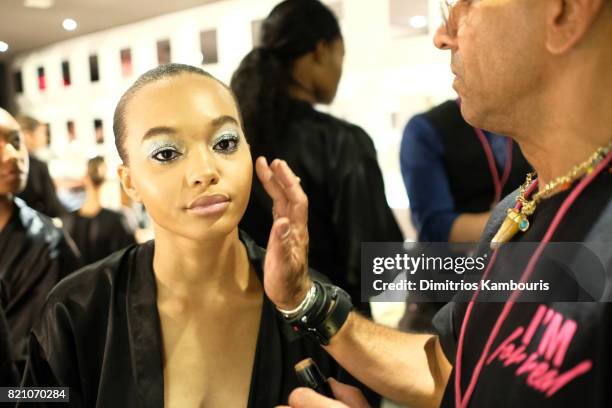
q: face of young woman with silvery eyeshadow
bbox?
[120,73,253,240]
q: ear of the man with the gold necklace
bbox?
[546,0,606,55]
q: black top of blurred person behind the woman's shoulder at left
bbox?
[62,208,136,265]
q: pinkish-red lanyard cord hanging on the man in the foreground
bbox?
[455,153,612,408]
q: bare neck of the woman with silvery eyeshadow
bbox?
[153,226,261,297]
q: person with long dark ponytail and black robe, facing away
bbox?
[231,0,403,312]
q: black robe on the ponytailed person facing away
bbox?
[240,100,403,312]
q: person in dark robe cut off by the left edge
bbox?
[0,109,80,370]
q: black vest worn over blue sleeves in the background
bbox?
[424,101,532,213]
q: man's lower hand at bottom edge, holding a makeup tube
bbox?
[276,378,370,408]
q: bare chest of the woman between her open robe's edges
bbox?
[160,296,261,407]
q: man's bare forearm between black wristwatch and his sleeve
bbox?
[326,312,452,407]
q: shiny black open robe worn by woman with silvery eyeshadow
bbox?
[23,233,378,408]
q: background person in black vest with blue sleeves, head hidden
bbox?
[400,100,531,331]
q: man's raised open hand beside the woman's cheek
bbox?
[255,157,312,310]
